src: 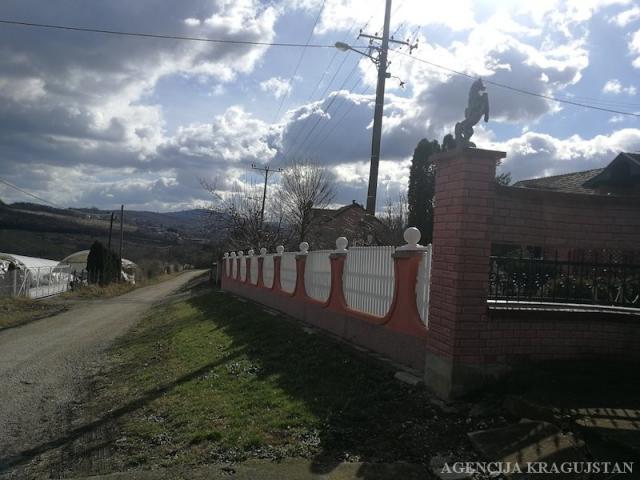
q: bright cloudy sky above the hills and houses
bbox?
[0,0,640,211]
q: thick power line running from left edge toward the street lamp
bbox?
[0,19,364,48]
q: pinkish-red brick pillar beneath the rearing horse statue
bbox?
[425,148,506,397]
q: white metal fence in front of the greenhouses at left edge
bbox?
[0,265,73,298]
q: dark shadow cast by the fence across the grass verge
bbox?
[179,293,456,478]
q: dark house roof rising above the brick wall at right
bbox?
[513,152,640,197]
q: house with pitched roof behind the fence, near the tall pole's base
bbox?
[308,200,393,250]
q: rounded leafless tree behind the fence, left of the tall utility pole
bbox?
[280,160,335,246]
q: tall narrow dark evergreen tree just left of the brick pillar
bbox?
[407,138,441,244]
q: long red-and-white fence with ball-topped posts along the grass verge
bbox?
[221,228,431,370]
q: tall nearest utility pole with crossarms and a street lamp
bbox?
[336,0,418,215]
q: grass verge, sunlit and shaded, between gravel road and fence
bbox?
[77,291,466,469]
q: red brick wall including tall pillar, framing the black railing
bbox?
[425,149,640,397]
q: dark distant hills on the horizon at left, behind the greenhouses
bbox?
[0,202,228,266]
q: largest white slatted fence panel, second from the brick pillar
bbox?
[343,247,395,317]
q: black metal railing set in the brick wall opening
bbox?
[489,255,640,308]
